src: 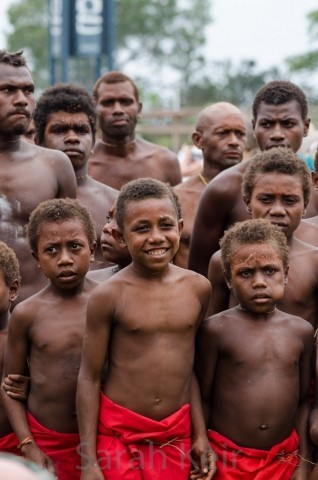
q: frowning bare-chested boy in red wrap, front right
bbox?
[192,220,314,480]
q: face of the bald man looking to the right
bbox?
[193,112,246,170]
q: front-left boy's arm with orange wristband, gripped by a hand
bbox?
[1,306,55,473]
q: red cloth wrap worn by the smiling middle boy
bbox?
[97,393,191,480]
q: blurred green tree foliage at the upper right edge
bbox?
[287,10,318,72]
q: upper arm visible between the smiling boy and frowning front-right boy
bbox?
[207,250,230,317]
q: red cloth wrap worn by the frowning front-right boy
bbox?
[208,430,299,480]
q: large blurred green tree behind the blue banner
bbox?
[7,0,211,87]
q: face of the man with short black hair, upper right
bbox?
[252,100,310,152]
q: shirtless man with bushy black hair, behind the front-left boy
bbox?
[34,84,118,270]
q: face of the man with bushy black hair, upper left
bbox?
[42,111,93,171]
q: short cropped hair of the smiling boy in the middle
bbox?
[116,178,182,229]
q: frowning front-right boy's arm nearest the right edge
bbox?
[292,325,314,480]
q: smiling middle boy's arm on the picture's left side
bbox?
[76,285,113,480]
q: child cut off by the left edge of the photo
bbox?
[0,242,20,454]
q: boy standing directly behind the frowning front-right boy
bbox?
[208,148,318,329]
